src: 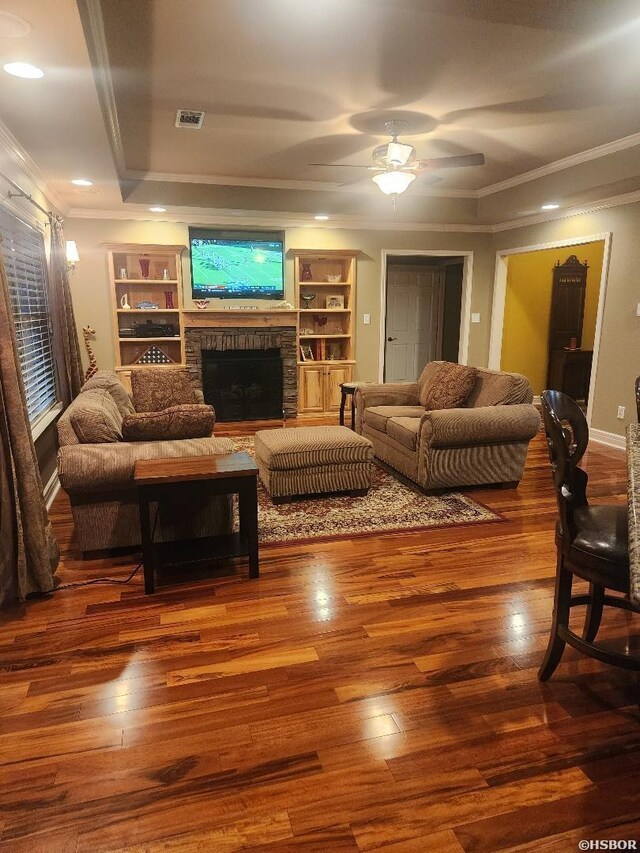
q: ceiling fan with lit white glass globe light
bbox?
[309,120,484,196]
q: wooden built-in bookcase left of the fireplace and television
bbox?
[105,243,186,384]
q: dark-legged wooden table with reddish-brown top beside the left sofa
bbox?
[133,453,259,594]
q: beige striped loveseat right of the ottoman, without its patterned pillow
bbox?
[355,361,540,490]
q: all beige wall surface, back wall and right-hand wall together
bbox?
[66,204,640,435]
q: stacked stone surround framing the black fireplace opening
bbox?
[184,326,298,418]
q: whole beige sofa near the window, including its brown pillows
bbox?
[58,369,233,552]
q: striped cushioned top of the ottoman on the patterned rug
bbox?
[254,426,373,471]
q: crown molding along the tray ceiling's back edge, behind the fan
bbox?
[122,169,477,198]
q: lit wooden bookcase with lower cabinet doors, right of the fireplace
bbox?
[293,249,358,414]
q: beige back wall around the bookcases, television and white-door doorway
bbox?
[65,219,494,380]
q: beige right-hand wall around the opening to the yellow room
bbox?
[493,203,640,435]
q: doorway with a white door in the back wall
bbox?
[381,253,467,382]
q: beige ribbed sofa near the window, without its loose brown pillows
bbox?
[58,371,233,552]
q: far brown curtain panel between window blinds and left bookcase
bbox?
[49,216,84,403]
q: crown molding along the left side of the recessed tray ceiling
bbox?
[77,0,126,175]
